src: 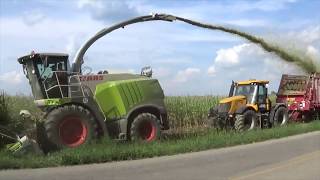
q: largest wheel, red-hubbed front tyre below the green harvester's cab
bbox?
[44,105,97,149]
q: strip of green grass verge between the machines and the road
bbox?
[0,120,320,169]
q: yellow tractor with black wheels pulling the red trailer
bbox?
[208,80,288,132]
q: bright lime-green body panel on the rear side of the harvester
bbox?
[94,78,164,119]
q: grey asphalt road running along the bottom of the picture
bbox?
[0,131,320,180]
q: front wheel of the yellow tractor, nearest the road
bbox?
[234,110,257,132]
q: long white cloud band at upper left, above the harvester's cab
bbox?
[0,16,103,40]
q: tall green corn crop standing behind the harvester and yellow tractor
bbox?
[2,94,222,132]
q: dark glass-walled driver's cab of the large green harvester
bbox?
[18,52,69,100]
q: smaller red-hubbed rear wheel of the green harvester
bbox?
[129,113,160,142]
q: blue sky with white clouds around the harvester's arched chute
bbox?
[0,0,320,95]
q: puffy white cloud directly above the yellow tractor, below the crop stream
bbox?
[207,43,301,76]
